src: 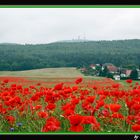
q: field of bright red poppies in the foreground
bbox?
[0,77,140,133]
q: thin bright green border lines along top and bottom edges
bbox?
[0,5,140,135]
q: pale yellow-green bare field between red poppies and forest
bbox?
[0,67,104,79]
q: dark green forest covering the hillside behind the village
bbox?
[0,39,140,71]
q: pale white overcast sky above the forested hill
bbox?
[0,8,140,44]
